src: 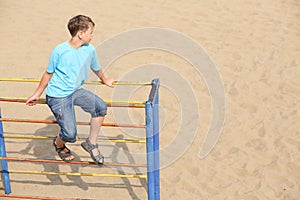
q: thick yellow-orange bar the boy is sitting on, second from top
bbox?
[0,97,145,108]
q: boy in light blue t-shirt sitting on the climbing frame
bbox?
[26,15,114,165]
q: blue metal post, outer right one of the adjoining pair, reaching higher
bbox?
[153,80,160,200]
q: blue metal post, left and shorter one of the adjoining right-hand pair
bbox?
[145,102,155,200]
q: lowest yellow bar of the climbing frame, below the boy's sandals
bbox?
[1,170,147,179]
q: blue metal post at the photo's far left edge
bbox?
[0,108,11,194]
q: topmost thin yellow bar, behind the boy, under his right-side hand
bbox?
[0,78,151,86]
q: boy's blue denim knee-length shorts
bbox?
[46,89,107,142]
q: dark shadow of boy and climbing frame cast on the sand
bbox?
[1,117,147,199]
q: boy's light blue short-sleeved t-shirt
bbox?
[46,41,101,97]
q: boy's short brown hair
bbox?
[68,15,95,37]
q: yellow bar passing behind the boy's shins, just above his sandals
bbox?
[3,134,146,143]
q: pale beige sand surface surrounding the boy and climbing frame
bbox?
[0,0,300,200]
